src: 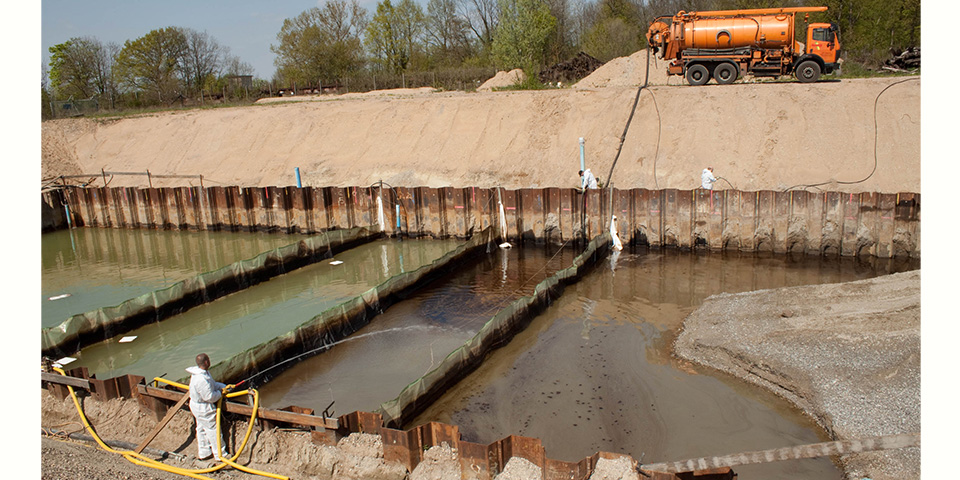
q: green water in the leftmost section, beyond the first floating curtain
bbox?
[40,227,302,327]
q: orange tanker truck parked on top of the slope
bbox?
[647,7,840,85]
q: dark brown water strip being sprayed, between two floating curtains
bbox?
[259,248,575,414]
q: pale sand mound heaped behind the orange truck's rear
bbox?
[573,49,682,89]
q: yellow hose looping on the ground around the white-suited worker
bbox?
[53,367,289,480]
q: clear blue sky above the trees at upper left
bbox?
[40,0,386,80]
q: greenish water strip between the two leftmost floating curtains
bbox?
[69,239,461,380]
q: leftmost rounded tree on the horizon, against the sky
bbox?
[50,37,114,99]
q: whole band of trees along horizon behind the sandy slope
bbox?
[41,0,920,109]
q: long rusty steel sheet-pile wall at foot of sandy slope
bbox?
[41,184,920,258]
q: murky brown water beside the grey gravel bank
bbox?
[405,250,919,480]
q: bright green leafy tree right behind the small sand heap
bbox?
[493,0,557,72]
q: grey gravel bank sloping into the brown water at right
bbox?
[675,270,920,480]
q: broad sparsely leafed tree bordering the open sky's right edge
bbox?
[270,0,367,85]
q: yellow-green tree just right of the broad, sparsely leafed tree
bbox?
[366,0,425,73]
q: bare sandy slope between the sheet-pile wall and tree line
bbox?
[42,52,921,193]
